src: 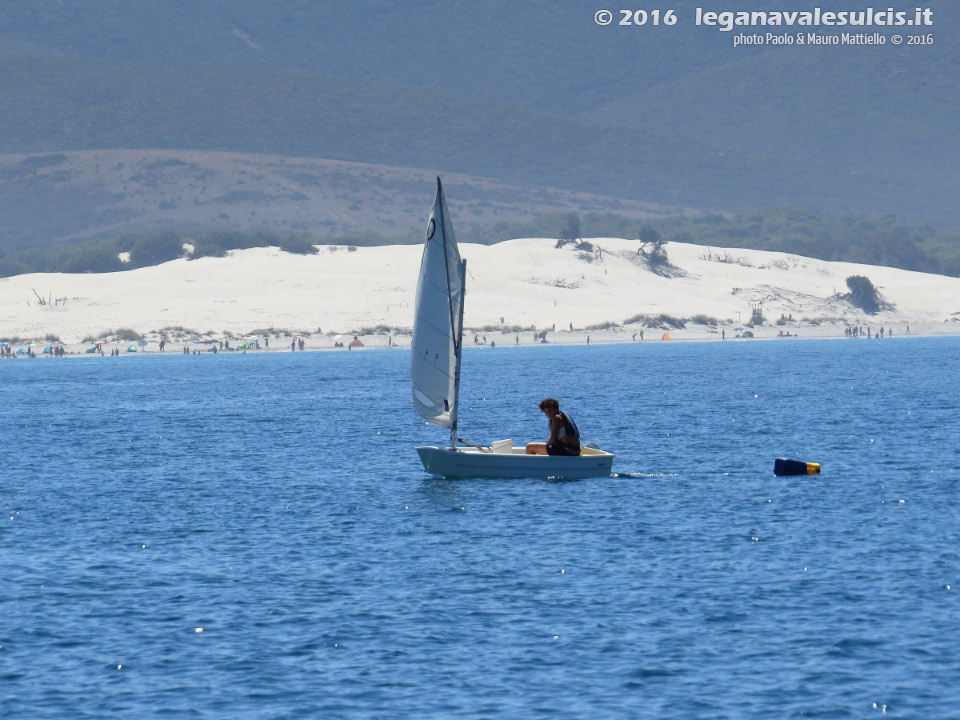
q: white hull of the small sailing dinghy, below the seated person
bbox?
[417,447,614,479]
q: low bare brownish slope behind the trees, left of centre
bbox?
[0,150,671,248]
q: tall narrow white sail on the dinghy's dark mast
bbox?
[410,177,466,436]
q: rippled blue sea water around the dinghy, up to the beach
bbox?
[0,338,960,719]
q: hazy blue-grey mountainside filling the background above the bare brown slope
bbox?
[0,0,960,250]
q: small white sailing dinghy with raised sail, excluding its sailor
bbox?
[410,177,614,478]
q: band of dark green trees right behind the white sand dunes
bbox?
[0,207,960,277]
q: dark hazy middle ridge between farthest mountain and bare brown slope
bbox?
[0,56,939,215]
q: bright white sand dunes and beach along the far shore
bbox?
[0,238,960,354]
